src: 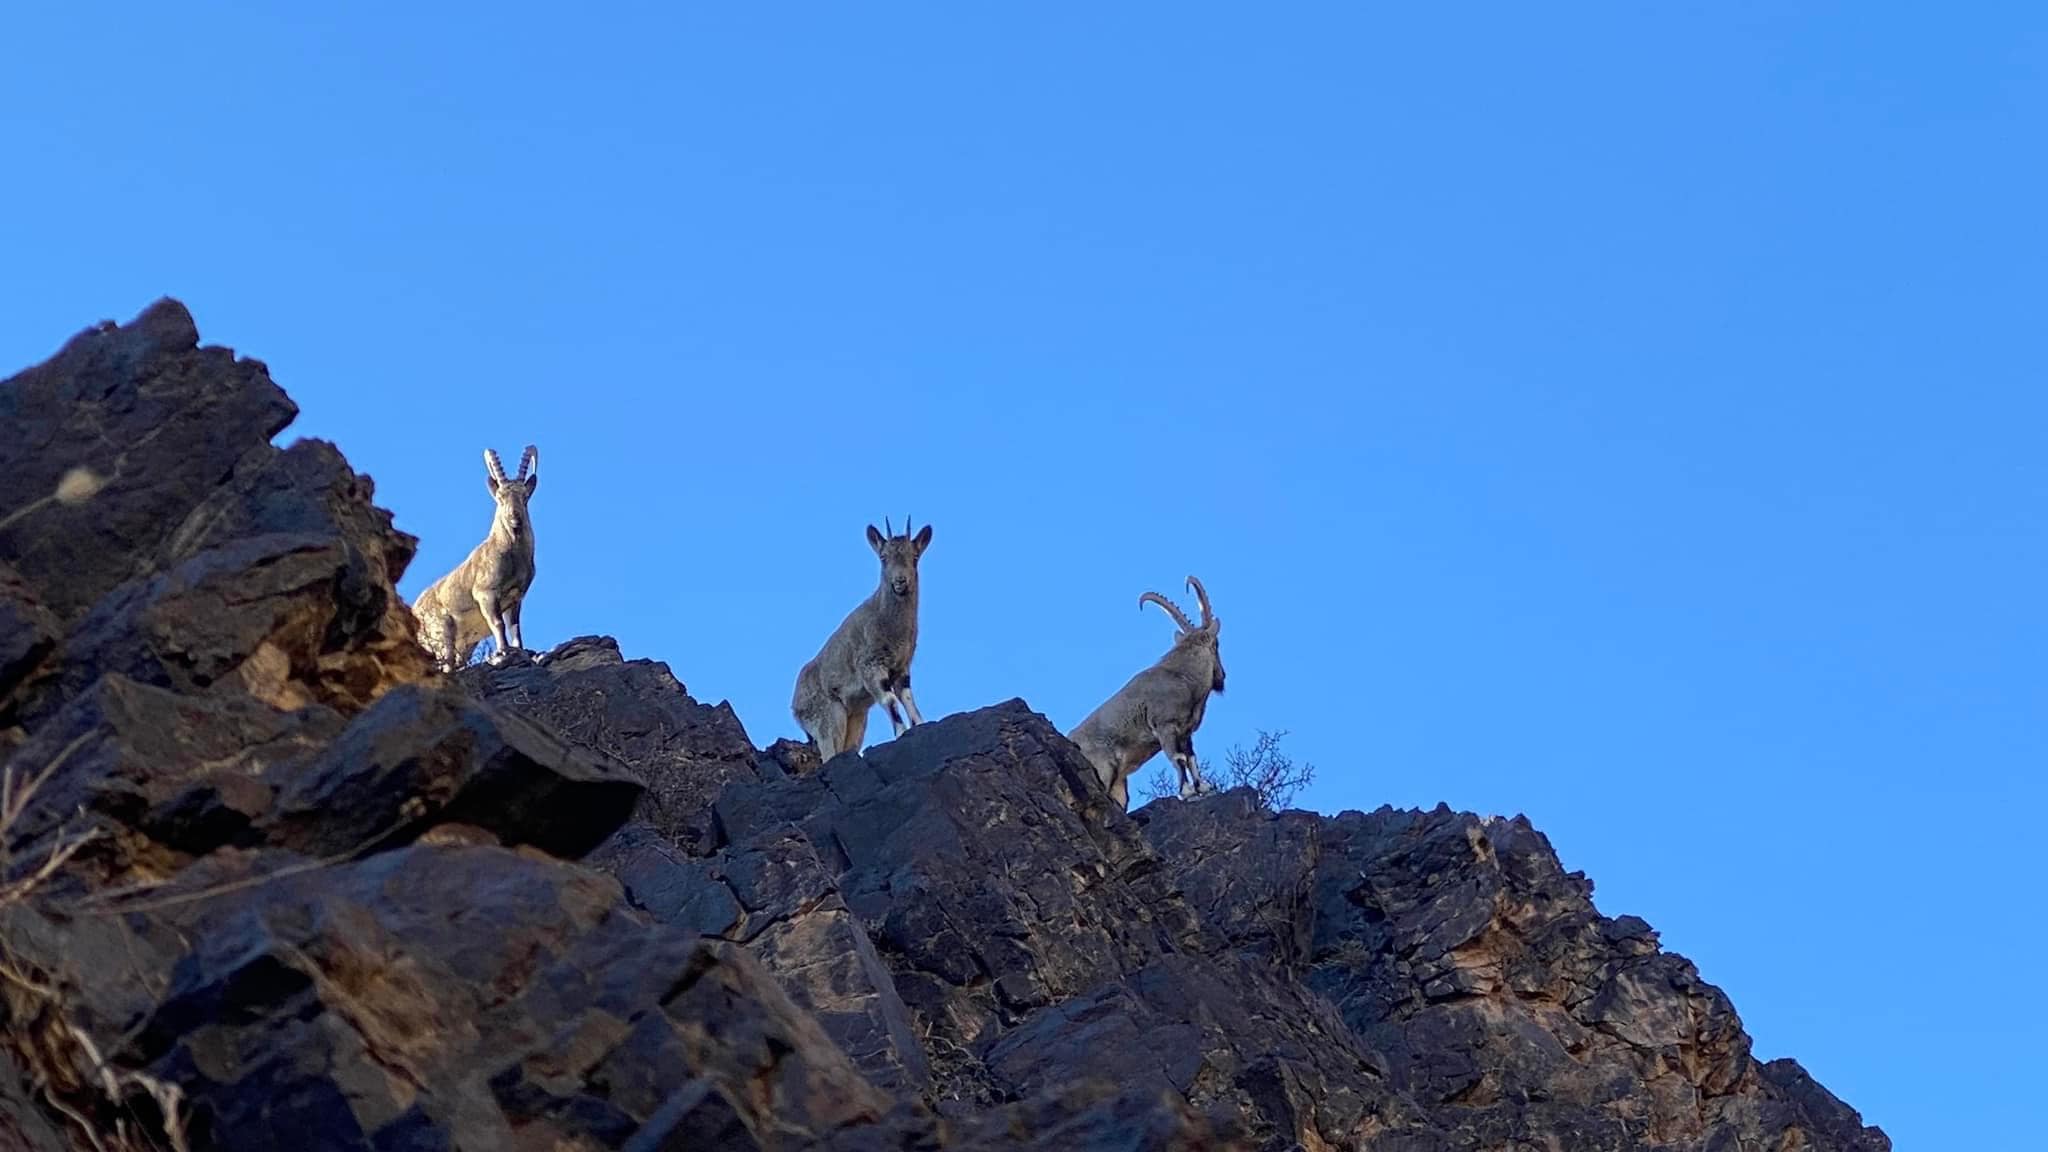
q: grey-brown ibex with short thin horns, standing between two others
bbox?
[788,517,932,763]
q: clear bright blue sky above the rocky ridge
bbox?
[0,2,2048,1148]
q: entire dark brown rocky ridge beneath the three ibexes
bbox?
[0,301,1890,1152]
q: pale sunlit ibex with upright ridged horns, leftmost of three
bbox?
[412,445,541,672]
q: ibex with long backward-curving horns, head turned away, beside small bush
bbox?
[1067,576,1223,808]
